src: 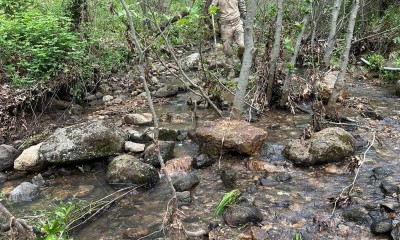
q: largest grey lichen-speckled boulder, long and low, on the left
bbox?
[39,121,126,163]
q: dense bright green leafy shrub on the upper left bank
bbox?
[0,8,85,86]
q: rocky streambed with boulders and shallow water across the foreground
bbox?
[0,62,400,239]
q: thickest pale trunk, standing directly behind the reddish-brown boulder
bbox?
[232,0,257,119]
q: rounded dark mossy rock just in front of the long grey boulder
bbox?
[106,154,160,186]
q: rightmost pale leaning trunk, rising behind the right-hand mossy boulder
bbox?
[328,0,360,108]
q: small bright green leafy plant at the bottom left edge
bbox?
[38,202,76,240]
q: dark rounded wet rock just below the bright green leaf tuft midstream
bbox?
[222,204,263,227]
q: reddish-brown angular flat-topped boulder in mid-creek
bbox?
[195,120,267,155]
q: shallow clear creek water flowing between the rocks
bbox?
[0,75,400,239]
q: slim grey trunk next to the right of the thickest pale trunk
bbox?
[267,0,283,104]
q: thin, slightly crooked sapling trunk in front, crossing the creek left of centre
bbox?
[120,0,178,217]
